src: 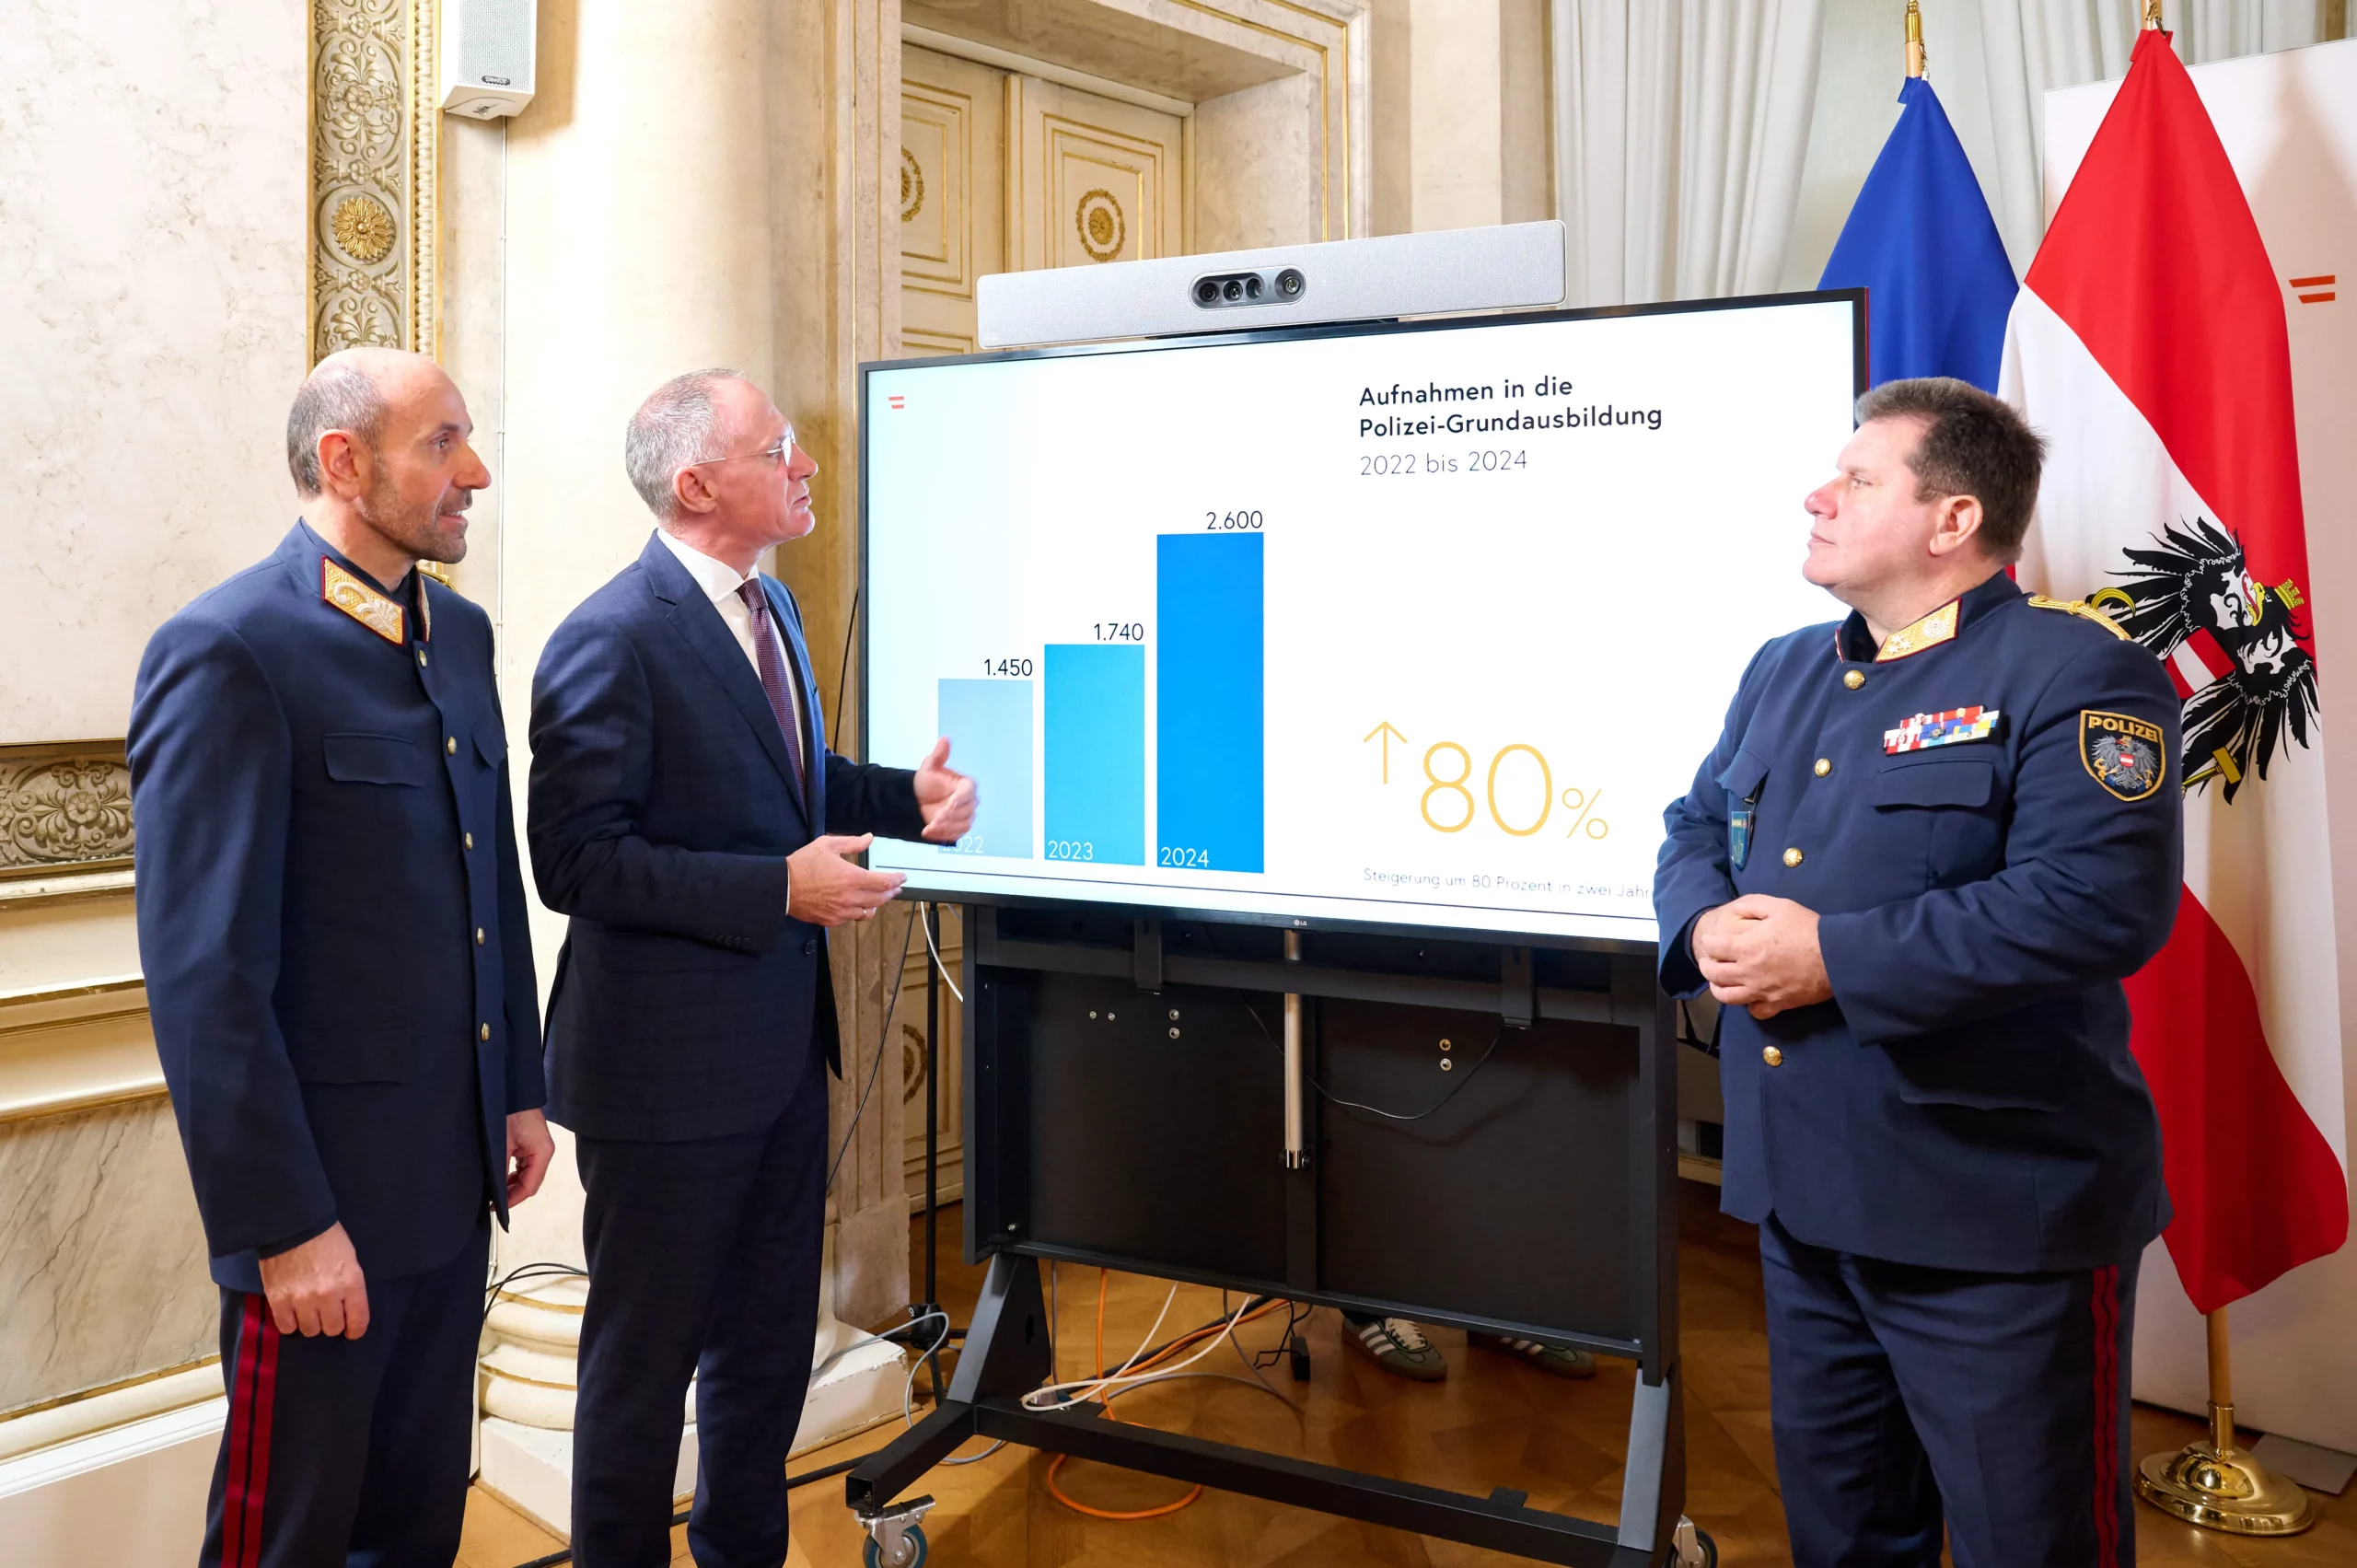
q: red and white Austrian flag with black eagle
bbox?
[2001,30,2348,1311]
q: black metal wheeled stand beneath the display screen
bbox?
[846,905,1685,1568]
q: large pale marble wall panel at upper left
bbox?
[0,0,308,743]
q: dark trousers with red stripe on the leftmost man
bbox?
[198,1210,490,1568]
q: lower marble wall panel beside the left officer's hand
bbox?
[0,1097,222,1412]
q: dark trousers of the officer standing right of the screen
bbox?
[1760,1214,2138,1568]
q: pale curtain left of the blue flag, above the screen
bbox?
[1549,0,1824,304]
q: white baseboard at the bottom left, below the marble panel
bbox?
[0,1399,228,1568]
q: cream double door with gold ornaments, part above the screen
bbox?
[900,45,1186,356]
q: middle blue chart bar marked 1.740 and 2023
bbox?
[1044,644,1145,865]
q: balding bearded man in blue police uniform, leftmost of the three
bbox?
[130,349,552,1568]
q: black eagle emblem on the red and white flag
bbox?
[2096,517,2316,802]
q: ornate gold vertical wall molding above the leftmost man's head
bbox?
[308,0,441,363]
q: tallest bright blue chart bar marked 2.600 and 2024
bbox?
[1155,533,1266,873]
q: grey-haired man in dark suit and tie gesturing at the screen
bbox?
[528,370,973,1568]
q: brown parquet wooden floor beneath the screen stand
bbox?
[459,1184,2357,1568]
